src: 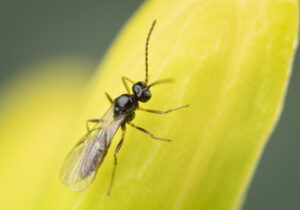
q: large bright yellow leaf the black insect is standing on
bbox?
[1,0,298,210]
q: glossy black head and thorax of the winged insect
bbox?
[114,82,151,123]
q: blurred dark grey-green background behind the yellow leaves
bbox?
[0,0,300,210]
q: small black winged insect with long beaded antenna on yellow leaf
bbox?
[60,20,188,195]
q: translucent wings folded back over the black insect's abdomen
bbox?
[60,104,125,191]
